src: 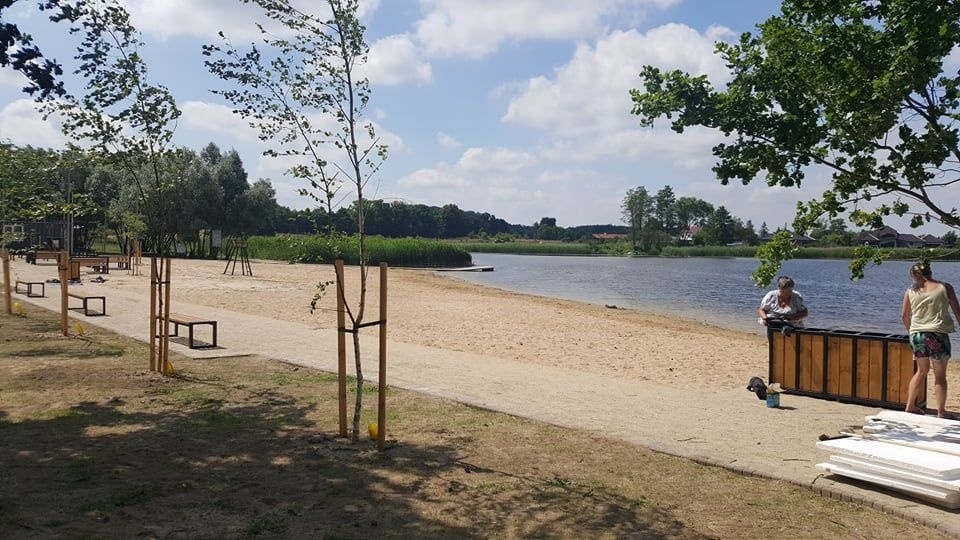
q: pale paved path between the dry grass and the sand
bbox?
[5,260,960,537]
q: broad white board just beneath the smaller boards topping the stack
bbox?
[817,438,960,480]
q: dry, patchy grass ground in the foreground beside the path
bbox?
[0,306,940,538]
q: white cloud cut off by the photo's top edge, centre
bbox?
[416,0,679,58]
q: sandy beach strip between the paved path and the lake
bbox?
[94,260,767,389]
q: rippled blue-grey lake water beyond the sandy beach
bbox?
[456,253,960,336]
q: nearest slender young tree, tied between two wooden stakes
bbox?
[203,0,387,441]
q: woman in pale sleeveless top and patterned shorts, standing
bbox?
[900,261,960,418]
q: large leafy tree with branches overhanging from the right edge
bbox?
[631,0,960,284]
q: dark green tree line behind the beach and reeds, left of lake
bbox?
[0,139,626,249]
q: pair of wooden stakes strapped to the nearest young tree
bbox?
[333,259,387,451]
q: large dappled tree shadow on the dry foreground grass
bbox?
[0,391,697,538]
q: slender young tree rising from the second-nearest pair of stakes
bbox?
[40,0,180,256]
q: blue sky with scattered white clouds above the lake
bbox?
[0,0,960,234]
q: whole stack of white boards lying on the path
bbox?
[817,411,960,509]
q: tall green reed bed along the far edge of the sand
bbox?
[247,235,472,267]
